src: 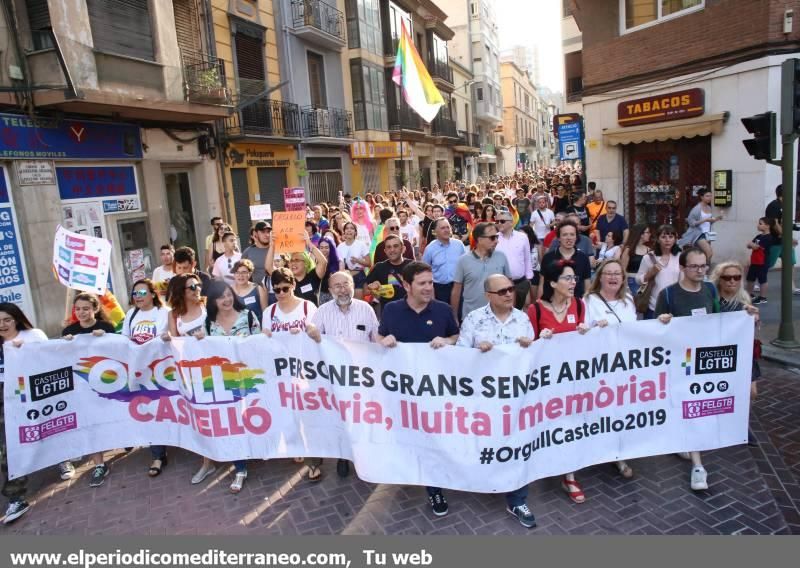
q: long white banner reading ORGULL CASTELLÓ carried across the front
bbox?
[4,312,754,492]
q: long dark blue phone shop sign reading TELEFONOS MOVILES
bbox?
[0,113,142,160]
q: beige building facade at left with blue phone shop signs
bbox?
[0,0,232,334]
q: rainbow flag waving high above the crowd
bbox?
[392,21,444,122]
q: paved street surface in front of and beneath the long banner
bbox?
[0,364,800,535]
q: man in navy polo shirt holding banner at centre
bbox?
[378,261,458,517]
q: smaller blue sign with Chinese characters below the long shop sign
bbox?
[56,166,136,201]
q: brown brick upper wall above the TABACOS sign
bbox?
[570,0,800,95]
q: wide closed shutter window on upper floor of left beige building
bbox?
[86,0,155,61]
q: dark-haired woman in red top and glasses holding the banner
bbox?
[528,259,589,503]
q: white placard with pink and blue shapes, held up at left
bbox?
[53,225,111,294]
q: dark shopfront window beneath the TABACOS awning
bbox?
[623,136,711,232]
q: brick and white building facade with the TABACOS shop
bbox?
[570,0,800,261]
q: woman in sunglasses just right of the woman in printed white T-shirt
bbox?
[165,274,217,485]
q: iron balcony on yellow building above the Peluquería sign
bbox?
[225,99,302,139]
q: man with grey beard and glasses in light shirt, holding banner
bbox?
[306,271,378,477]
